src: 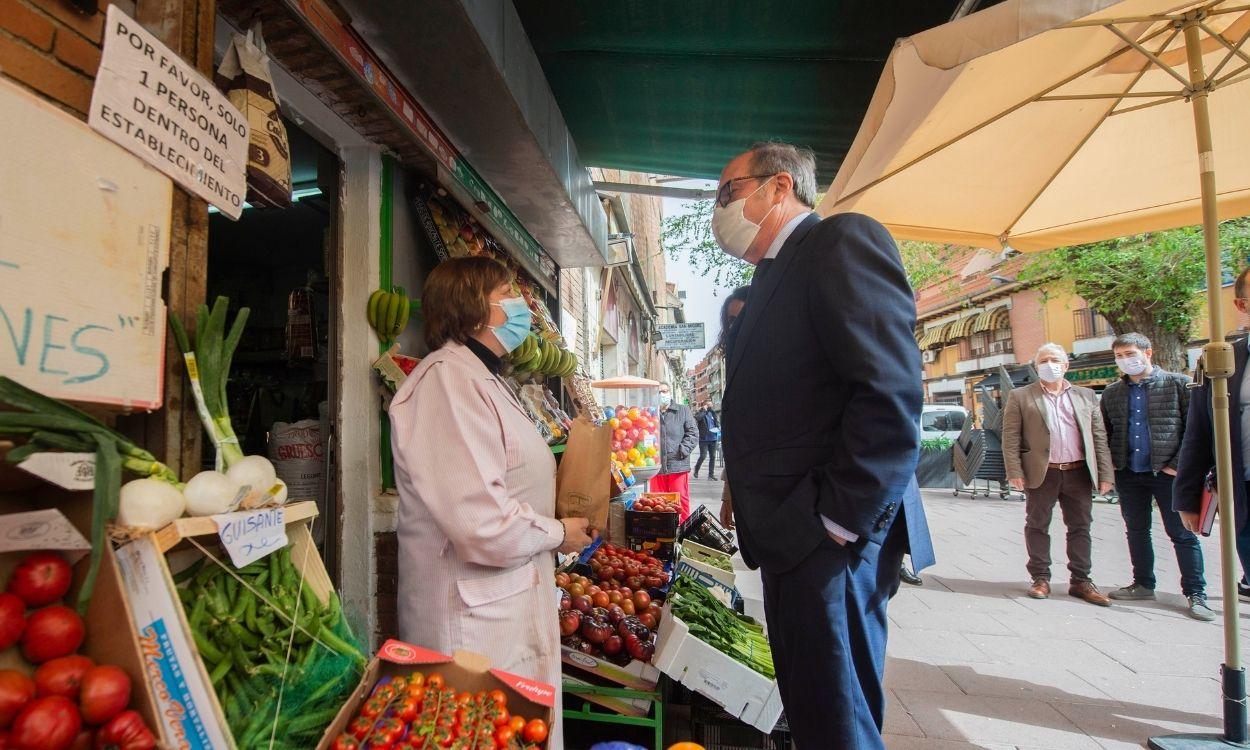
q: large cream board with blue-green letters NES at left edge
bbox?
[0,80,173,409]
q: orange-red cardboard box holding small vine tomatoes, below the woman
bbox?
[318,640,555,750]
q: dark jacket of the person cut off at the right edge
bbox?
[1173,339,1250,530]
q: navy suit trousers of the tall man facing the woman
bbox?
[763,514,908,750]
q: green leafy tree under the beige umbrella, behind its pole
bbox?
[1020,219,1250,371]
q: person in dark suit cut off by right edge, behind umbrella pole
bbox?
[1173,269,1250,601]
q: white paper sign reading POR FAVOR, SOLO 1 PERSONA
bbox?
[88,5,249,219]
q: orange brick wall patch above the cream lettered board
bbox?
[0,0,135,119]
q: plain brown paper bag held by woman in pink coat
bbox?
[555,418,613,530]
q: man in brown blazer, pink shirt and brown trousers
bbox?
[1003,344,1114,606]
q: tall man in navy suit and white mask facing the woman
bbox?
[713,143,933,750]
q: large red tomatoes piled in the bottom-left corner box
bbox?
[0,553,156,750]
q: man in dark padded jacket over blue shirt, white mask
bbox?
[1101,334,1215,621]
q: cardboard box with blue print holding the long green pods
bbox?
[118,501,333,750]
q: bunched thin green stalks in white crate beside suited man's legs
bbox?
[668,576,776,680]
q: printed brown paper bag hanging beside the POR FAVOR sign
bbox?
[218,23,291,209]
